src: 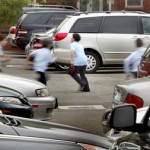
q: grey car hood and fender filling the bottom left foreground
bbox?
[0,114,113,150]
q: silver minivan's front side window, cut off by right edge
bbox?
[142,17,150,34]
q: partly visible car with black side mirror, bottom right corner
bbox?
[109,105,150,150]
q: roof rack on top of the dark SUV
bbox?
[26,4,77,10]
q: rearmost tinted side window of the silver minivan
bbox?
[70,17,102,33]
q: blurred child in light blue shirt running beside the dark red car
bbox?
[124,38,146,79]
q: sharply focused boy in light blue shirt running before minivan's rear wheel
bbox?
[70,33,90,92]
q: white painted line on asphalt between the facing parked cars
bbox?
[58,105,105,110]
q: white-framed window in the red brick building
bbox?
[125,0,143,7]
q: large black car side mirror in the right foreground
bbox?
[109,104,137,130]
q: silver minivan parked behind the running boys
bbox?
[54,11,150,73]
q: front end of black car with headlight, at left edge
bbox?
[0,86,33,118]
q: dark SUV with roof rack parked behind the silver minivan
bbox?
[15,8,78,49]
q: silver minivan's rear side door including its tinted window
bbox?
[97,15,140,64]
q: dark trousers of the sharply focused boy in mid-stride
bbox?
[71,66,89,90]
